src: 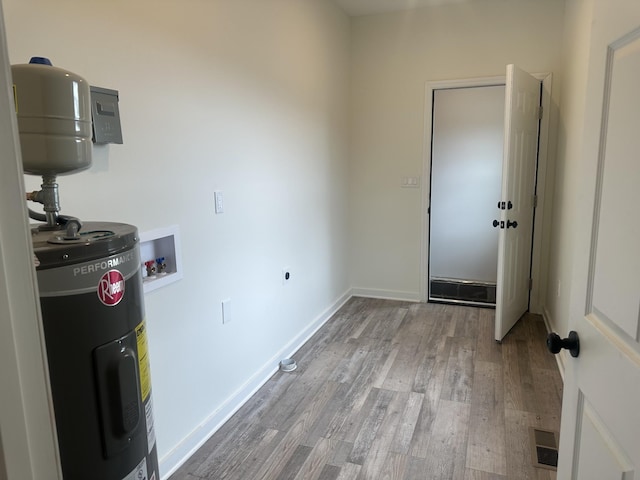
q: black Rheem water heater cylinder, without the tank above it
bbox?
[33,222,159,480]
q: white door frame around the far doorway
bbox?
[420,69,553,314]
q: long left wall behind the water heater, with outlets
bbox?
[4,0,350,473]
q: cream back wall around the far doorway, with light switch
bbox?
[350,0,564,299]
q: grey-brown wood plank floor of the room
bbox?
[171,297,562,480]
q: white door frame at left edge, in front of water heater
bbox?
[0,0,62,480]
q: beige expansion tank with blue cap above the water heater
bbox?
[11,57,92,175]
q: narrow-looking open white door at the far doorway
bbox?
[494,65,540,341]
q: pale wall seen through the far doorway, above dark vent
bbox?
[429,85,505,284]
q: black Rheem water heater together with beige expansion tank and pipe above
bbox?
[12,58,159,480]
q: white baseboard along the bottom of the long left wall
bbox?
[160,290,352,479]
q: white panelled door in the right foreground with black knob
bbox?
[558,0,640,480]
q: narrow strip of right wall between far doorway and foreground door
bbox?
[545,0,593,344]
